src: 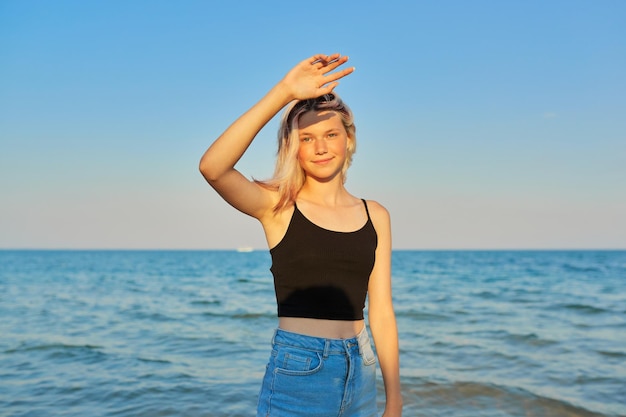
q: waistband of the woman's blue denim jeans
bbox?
[272,327,370,356]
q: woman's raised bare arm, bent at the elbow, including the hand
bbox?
[200,54,354,219]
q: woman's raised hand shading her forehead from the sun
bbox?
[281,54,354,100]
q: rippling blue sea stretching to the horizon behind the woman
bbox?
[0,250,626,417]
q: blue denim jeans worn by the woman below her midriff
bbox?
[257,329,377,417]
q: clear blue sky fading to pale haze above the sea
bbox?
[0,0,626,249]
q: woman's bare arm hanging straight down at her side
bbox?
[368,202,402,417]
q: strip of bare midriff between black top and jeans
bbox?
[278,317,365,339]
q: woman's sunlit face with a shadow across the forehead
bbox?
[298,110,351,181]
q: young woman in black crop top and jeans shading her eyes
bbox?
[200,54,402,417]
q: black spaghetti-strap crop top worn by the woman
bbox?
[270,200,378,320]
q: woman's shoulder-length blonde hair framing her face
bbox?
[256,93,356,213]
